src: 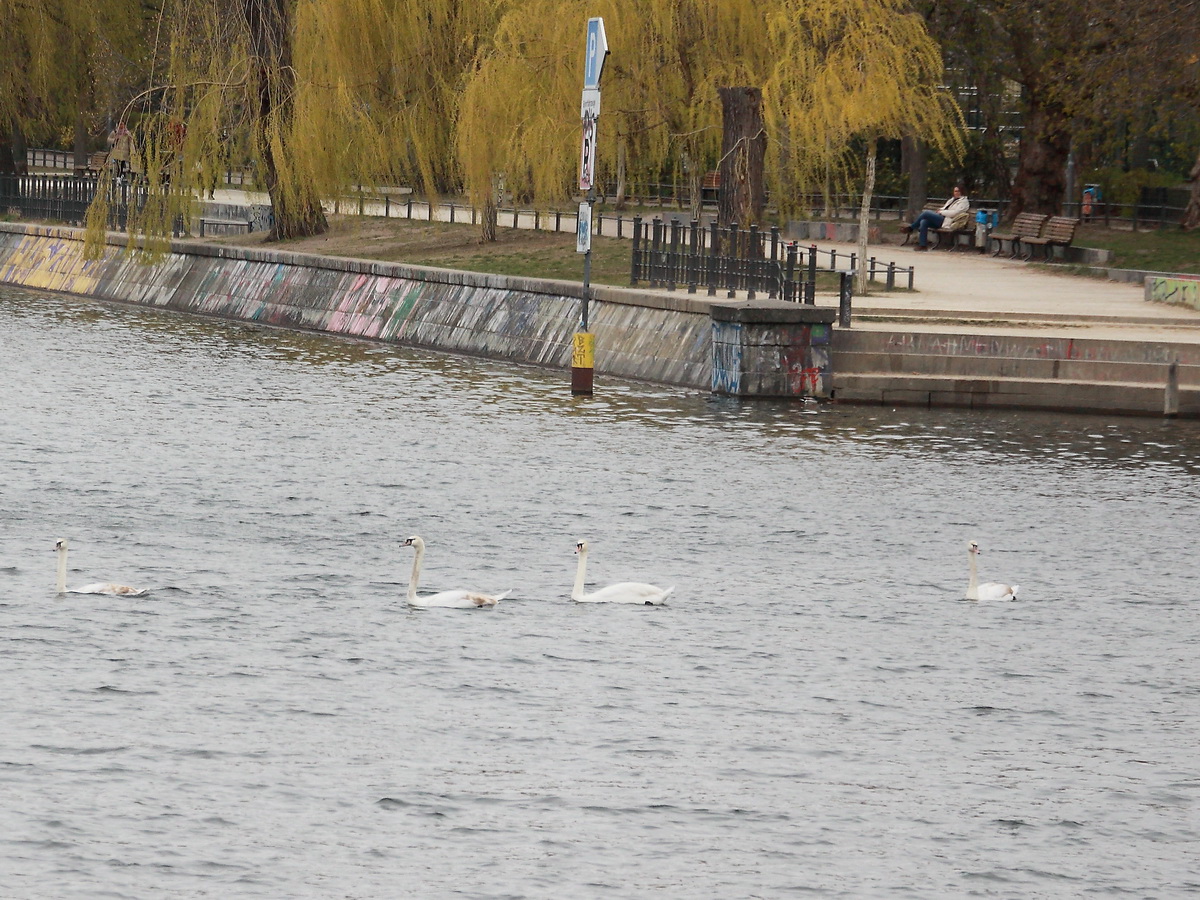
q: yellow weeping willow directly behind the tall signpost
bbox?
[456,0,720,239]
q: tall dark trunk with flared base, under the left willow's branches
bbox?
[241,0,329,241]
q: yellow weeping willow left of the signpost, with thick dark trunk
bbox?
[89,0,500,247]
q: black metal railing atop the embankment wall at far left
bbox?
[0,175,154,232]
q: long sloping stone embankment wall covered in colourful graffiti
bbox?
[0,223,710,391]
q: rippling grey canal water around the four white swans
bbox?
[0,288,1200,900]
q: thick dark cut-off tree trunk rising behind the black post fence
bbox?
[716,88,767,226]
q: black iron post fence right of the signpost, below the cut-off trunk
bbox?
[629,216,913,304]
